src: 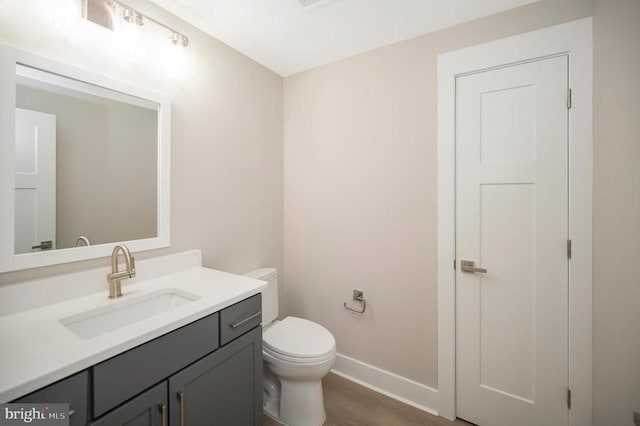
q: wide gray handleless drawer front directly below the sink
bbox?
[93,313,218,417]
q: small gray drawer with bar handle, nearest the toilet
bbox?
[220,293,262,345]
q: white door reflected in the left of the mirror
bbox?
[15,108,56,254]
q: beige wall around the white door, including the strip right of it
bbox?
[284,0,640,426]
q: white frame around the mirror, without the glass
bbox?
[0,45,171,272]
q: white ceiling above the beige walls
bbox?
[151,0,537,76]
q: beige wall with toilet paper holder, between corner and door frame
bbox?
[284,0,593,388]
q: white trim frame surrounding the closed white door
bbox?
[437,18,593,426]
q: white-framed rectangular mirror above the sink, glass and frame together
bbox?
[0,48,170,272]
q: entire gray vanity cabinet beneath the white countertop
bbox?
[14,294,262,426]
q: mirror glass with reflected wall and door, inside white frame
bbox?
[15,65,159,254]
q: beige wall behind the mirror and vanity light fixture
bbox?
[0,0,283,288]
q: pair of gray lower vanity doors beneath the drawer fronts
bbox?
[90,318,262,426]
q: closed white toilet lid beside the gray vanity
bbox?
[262,317,336,358]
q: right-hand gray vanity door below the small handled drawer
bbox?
[169,327,262,426]
